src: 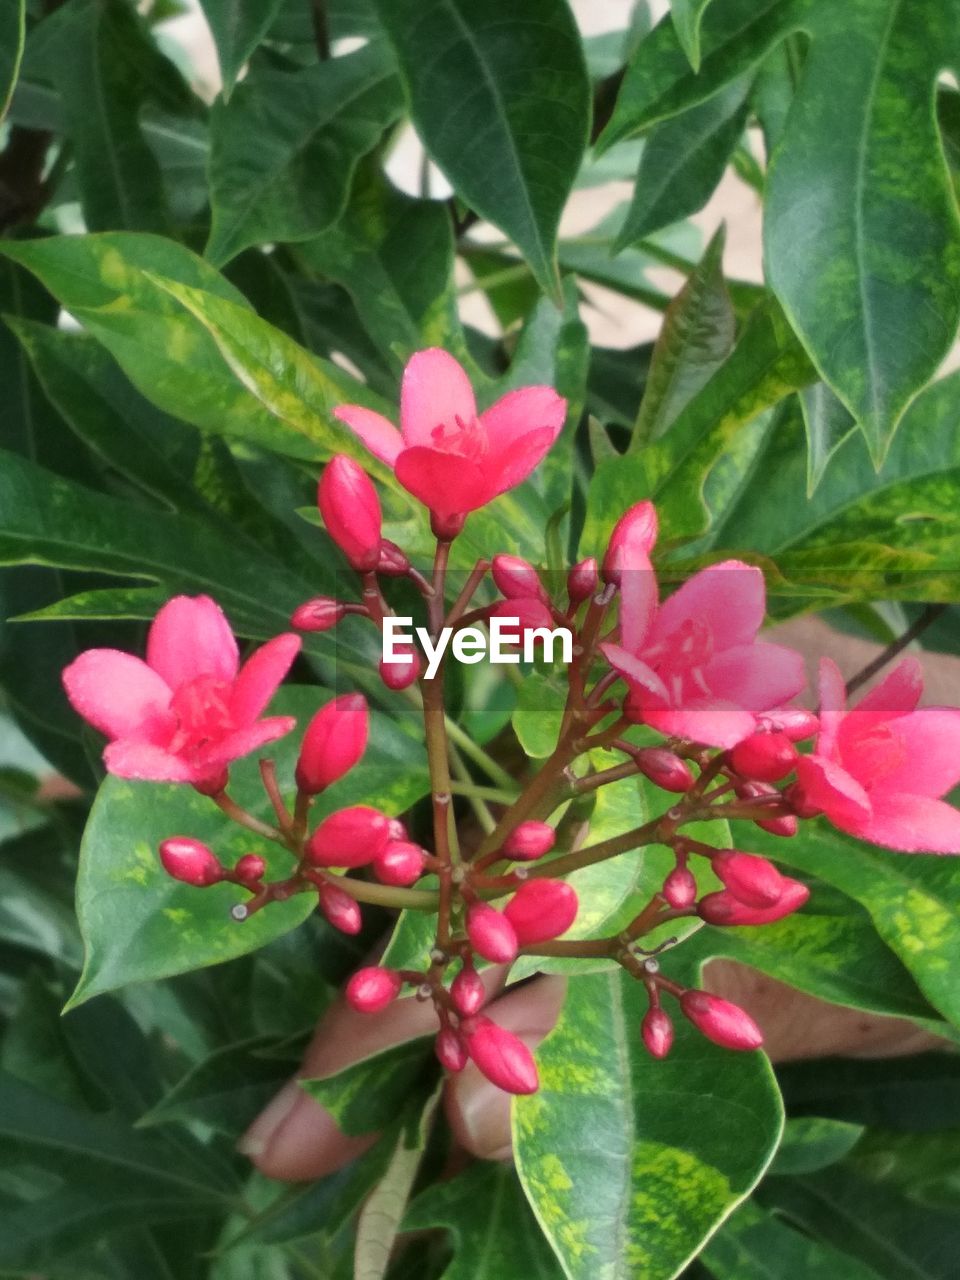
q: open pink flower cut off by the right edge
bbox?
[796,658,960,854]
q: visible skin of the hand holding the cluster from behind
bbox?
[239,618,960,1180]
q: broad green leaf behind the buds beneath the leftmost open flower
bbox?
[70,689,429,1006]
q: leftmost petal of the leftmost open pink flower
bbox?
[63,649,177,742]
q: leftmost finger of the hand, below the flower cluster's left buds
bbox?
[237,968,504,1181]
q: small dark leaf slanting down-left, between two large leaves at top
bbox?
[616,77,750,250]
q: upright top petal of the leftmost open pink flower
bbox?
[147,595,238,689]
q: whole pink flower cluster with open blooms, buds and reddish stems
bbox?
[64,351,960,1093]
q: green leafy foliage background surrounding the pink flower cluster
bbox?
[0,0,960,1280]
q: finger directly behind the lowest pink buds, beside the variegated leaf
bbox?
[444,977,567,1160]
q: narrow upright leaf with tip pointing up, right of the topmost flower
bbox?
[630,227,735,449]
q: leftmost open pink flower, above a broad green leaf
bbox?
[63,595,300,786]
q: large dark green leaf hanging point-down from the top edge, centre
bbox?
[378,0,590,294]
